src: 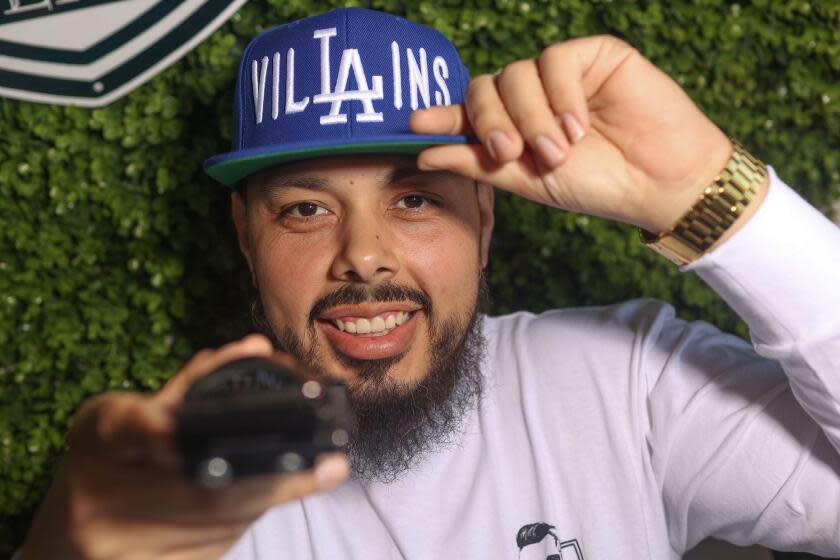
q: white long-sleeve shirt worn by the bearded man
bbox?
[225,170,840,560]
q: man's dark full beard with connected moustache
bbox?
[252,273,489,483]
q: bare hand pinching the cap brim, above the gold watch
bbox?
[411,36,731,232]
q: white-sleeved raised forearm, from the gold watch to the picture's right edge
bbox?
[684,166,840,450]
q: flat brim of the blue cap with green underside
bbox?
[204,134,478,189]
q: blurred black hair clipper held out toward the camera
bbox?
[177,358,351,487]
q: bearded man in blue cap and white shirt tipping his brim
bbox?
[20,5,840,560]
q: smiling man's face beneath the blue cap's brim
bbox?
[233,156,493,400]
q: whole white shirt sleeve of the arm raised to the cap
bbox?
[646,169,840,556]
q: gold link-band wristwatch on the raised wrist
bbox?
[639,142,767,266]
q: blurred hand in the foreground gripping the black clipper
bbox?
[18,336,349,560]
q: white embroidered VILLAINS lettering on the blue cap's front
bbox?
[251,27,451,125]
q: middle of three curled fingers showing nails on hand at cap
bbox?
[496,60,569,170]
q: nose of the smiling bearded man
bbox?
[332,215,400,284]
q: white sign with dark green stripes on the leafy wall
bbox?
[0,0,245,107]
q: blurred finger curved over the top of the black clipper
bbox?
[155,334,274,408]
